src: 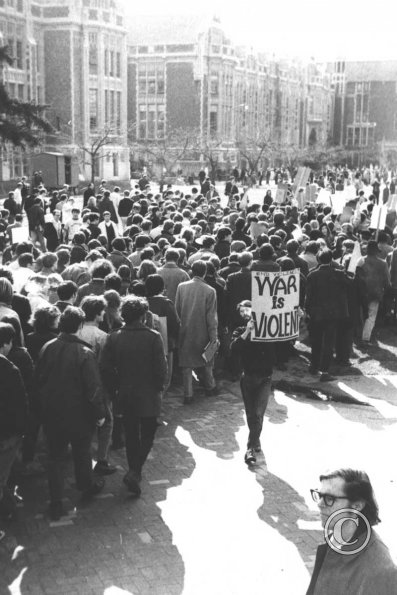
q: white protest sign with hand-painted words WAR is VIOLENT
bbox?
[251,269,300,343]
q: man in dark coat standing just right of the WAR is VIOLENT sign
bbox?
[305,249,348,382]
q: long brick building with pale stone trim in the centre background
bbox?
[128,15,333,171]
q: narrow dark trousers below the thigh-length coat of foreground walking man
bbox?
[123,411,157,475]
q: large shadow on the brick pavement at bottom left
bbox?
[0,403,195,595]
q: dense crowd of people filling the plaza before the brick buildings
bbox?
[0,166,397,592]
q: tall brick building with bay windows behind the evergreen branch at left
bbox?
[0,0,129,189]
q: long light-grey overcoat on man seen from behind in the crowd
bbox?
[175,277,218,368]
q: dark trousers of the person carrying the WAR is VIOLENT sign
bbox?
[240,373,272,448]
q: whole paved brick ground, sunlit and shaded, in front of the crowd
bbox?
[0,383,397,595]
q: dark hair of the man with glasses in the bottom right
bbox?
[320,468,380,526]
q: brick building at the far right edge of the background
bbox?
[331,60,397,159]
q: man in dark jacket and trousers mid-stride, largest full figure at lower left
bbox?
[36,306,105,520]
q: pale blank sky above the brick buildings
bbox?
[123,0,397,60]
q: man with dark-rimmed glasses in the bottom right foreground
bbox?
[306,469,397,595]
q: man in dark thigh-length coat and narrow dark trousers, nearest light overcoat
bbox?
[100,295,167,496]
